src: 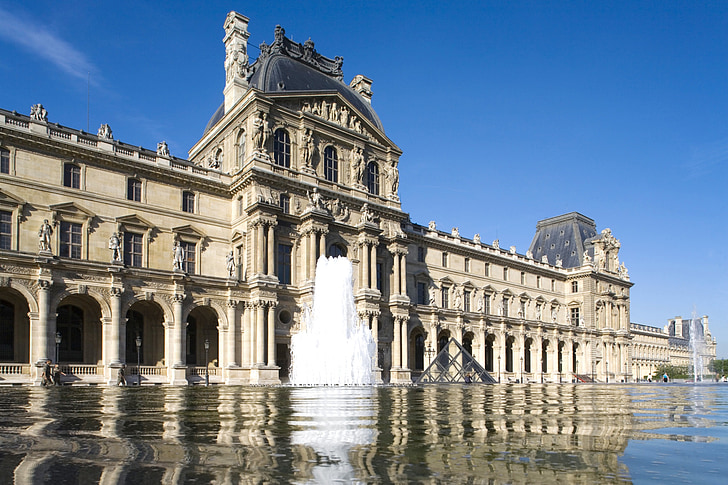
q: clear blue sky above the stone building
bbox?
[0,0,728,358]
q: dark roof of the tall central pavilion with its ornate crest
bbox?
[205,25,384,133]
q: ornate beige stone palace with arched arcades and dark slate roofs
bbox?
[0,12,632,384]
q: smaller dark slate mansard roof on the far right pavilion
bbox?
[529,212,597,268]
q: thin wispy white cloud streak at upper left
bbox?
[0,7,96,79]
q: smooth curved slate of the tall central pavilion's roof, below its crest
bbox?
[249,54,384,131]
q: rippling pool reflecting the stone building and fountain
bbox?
[0,383,728,485]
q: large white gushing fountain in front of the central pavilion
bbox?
[291,256,376,386]
